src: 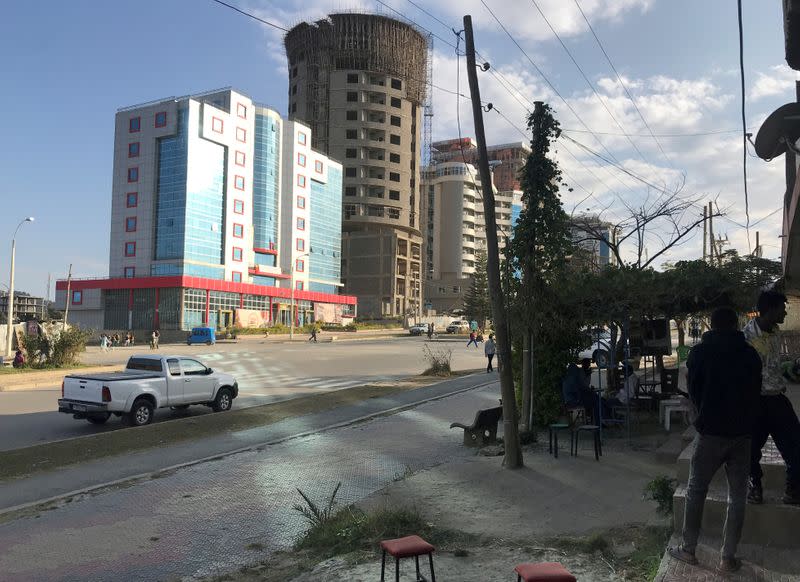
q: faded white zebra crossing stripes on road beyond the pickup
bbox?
[195,352,405,396]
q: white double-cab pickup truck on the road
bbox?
[58,356,239,426]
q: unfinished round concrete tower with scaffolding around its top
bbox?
[284,14,428,316]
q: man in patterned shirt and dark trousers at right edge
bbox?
[744,290,800,505]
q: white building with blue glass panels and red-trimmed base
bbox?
[57,89,355,330]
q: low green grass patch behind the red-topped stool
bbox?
[295,506,473,560]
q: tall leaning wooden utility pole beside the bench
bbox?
[464,15,523,469]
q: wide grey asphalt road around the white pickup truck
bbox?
[0,337,485,450]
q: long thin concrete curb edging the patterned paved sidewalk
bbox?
[0,376,499,517]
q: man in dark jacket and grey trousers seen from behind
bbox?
[669,307,761,572]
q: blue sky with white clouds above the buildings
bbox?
[0,0,800,296]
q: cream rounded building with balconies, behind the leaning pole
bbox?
[423,162,514,312]
